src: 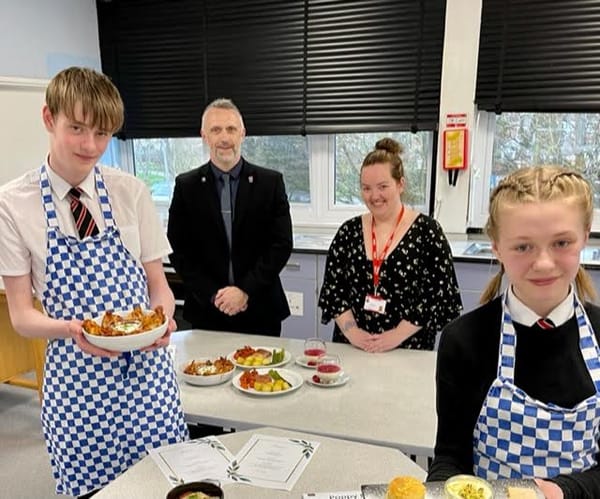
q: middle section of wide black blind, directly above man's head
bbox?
[205,0,305,135]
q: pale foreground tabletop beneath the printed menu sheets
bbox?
[94,428,425,499]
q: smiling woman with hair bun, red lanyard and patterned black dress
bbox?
[319,138,462,352]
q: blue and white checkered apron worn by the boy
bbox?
[40,166,187,496]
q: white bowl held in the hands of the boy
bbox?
[83,310,169,352]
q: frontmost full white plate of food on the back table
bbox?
[232,368,303,397]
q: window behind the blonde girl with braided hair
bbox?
[470,111,600,232]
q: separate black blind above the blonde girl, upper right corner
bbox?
[475,0,600,113]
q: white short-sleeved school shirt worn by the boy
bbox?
[0,163,172,298]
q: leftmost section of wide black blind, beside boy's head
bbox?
[97,0,206,138]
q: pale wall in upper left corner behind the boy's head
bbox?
[0,0,101,185]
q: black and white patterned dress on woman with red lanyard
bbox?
[319,214,462,350]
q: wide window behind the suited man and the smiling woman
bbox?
[115,132,433,228]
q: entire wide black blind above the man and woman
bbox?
[97,0,446,138]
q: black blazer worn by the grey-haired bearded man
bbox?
[167,160,292,335]
